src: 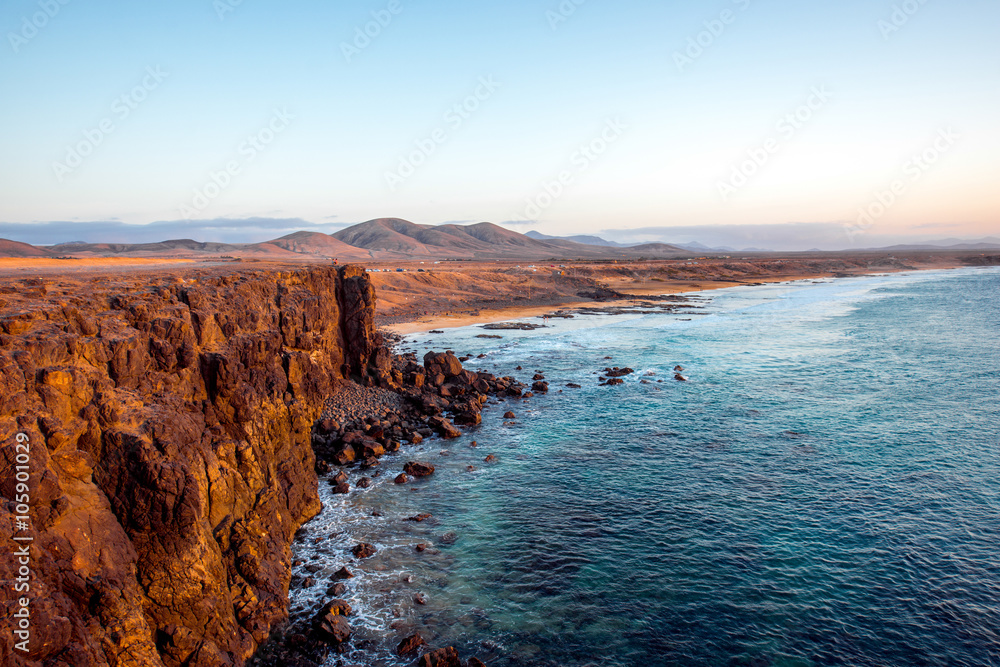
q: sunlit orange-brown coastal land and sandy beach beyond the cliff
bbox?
[372,253,970,335]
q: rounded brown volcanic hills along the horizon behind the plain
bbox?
[0,218,689,261]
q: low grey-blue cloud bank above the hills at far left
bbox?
[0,217,350,245]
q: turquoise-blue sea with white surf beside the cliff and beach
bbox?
[294,269,1000,667]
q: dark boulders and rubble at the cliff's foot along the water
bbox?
[253,351,536,667]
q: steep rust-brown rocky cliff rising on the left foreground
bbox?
[0,266,388,667]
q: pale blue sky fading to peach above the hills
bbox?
[0,0,1000,249]
